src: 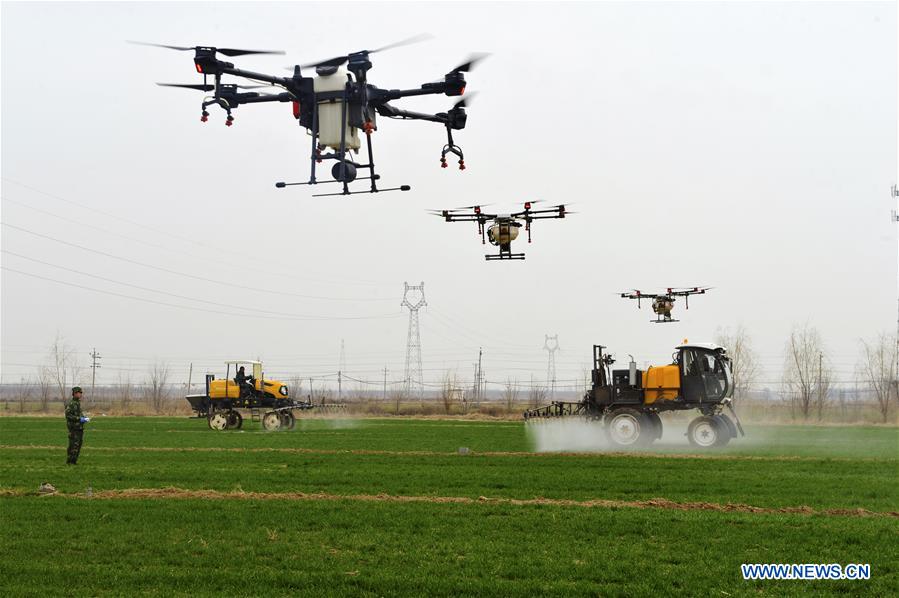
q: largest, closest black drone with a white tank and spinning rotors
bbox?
[132,36,486,197]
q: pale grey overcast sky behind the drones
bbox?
[0,2,897,386]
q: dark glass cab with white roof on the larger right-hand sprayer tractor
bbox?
[675,343,734,403]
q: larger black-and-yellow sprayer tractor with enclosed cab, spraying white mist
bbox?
[524,341,745,448]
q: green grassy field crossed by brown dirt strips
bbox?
[0,417,899,596]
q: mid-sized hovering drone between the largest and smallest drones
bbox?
[431,201,570,261]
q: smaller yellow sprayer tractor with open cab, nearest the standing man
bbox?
[187,360,314,432]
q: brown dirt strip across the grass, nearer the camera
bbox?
[0,487,899,518]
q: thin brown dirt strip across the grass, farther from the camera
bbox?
[0,444,895,462]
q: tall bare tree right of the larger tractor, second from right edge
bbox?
[783,323,831,420]
